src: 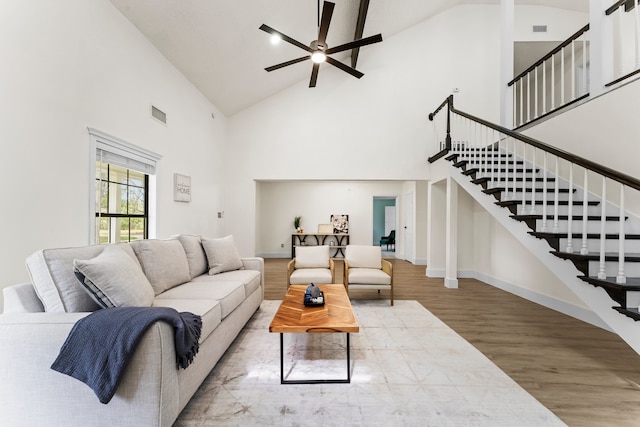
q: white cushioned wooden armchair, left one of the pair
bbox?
[287,245,335,285]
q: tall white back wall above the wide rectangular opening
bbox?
[224,6,499,253]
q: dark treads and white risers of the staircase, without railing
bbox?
[445,145,640,320]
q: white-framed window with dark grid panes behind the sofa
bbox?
[89,128,161,244]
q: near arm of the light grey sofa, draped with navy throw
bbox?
[0,313,180,426]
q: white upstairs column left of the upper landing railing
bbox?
[500,0,515,129]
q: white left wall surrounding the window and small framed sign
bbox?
[0,0,227,310]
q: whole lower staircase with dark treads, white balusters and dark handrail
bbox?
[429,97,640,353]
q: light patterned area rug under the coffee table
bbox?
[175,300,565,427]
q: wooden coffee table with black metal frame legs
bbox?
[269,284,360,384]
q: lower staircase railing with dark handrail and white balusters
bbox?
[429,95,640,284]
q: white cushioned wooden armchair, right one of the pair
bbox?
[344,245,393,305]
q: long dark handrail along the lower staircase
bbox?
[429,95,640,191]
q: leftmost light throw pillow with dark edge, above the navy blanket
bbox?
[73,245,154,308]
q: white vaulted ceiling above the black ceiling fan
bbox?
[110,0,589,116]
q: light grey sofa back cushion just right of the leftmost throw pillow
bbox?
[131,239,191,295]
